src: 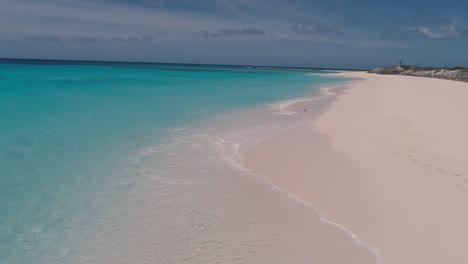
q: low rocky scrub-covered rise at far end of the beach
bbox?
[369,65,468,81]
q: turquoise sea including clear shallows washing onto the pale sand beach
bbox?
[0,61,372,264]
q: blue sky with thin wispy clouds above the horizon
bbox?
[0,0,468,68]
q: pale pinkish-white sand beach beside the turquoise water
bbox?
[244,72,468,264]
